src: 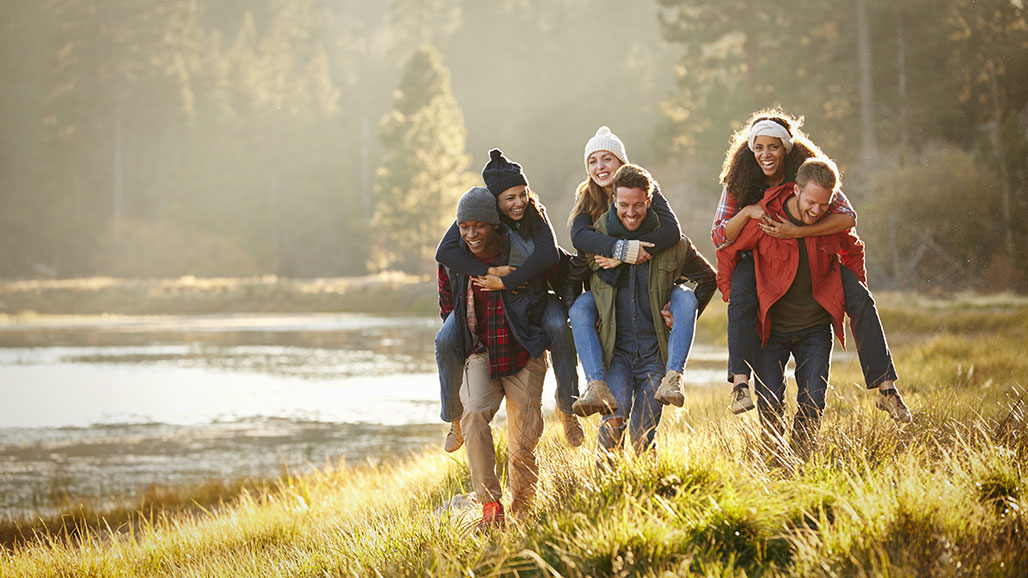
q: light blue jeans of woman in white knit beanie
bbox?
[571,285,699,382]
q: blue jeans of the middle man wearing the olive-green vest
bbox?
[596,345,664,454]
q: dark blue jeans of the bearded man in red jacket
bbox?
[754,323,834,432]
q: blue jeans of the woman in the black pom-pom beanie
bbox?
[436,295,579,422]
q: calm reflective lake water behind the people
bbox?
[0,314,725,516]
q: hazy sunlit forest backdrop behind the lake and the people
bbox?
[0,0,1028,290]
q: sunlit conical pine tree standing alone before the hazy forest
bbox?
[369,46,476,274]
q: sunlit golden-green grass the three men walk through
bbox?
[0,295,1028,577]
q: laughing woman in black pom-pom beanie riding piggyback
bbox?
[436,149,584,451]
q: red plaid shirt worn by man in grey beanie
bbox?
[439,254,531,380]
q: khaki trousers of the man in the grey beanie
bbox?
[461,353,546,515]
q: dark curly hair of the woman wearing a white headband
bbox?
[721,107,824,209]
